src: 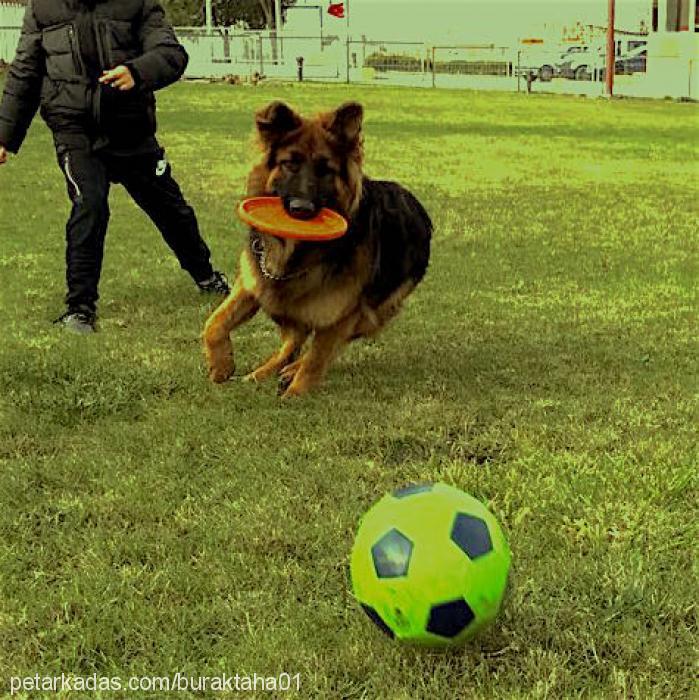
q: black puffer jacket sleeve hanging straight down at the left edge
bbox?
[0,0,45,153]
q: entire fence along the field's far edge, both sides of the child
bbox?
[0,26,688,99]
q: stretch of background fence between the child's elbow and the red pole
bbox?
[178,27,624,94]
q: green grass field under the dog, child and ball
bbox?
[0,78,699,700]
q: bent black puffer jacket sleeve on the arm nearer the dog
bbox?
[126,0,189,90]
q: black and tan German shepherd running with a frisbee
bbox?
[203,102,432,397]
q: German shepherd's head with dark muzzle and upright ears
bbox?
[248,102,363,219]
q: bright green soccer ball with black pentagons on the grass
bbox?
[350,483,510,646]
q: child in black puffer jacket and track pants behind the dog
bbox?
[0,0,229,332]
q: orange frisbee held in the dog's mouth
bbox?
[238,197,347,241]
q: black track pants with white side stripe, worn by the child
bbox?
[58,146,213,311]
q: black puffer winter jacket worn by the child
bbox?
[0,0,187,153]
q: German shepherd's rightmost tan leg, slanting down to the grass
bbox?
[282,312,359,399]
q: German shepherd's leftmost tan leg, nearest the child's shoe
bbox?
[203,276,260,383]
